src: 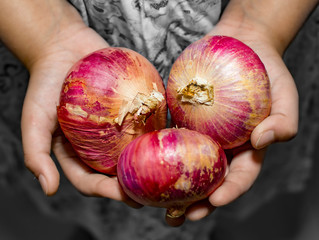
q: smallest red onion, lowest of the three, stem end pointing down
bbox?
[117,128,227,218]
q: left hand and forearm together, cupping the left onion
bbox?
[0,0,140,207]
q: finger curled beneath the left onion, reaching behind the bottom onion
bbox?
[53,136,142,208]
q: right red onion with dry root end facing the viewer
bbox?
[166,36,271,149]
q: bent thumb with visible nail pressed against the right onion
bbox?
[251,59,299,149]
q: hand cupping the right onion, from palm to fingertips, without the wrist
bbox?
[168,19,298,226]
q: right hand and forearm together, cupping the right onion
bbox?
[179,0,318,227]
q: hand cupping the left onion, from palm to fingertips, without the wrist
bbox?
[21,21,139,207]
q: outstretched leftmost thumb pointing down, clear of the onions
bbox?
[21,100,60,195]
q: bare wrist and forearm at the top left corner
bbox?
[0,0,85,70]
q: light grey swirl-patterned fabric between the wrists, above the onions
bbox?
[69,0,221,83]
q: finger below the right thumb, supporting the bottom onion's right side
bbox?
[209,149,265,207]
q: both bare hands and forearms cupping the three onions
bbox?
[0,0,318,226]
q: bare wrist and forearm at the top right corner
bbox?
[212,0,318,55]
